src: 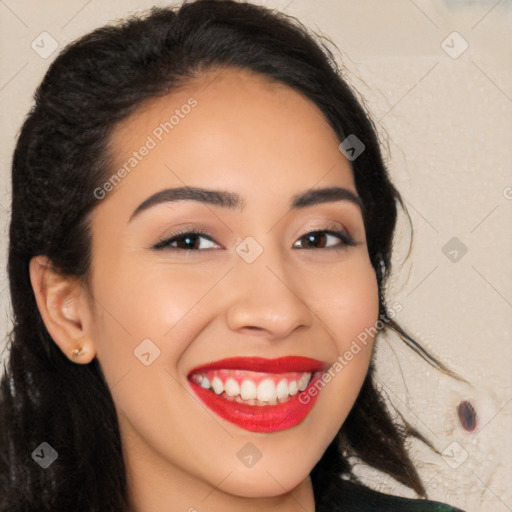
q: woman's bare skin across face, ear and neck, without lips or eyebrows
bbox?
[31,69,378,512]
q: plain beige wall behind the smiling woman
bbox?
[0,0,512,512]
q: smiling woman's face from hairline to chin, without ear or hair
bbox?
[85,70,378,510]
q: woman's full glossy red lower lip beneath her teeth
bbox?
[190,377,319,432]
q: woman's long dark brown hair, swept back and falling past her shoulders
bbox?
[0,0,464,512]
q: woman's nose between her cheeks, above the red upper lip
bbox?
[226,251,314,339]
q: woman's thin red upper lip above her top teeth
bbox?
[189,356,329,375]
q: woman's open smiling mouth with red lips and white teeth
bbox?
[188,356,327,432]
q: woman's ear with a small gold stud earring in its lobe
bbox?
[29,255,95,364]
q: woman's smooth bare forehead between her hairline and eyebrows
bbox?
[103,68,355,214]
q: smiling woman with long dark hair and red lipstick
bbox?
[0,0,466,512]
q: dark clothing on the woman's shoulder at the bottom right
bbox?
[317,479,464,512]
